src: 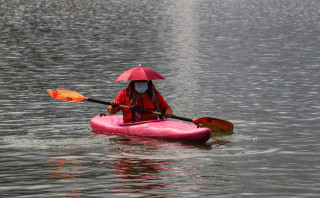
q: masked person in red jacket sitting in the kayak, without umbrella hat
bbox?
[108,80,173,123]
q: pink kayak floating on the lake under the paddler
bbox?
[90,115,211,143]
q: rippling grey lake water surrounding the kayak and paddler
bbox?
[0,0,320,197]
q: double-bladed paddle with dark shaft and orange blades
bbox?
[47,88,233,133]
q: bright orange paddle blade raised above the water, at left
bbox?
[47,88,88,102]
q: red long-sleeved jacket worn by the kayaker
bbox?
[113,90,170,123]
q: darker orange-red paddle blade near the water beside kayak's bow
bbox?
[192,117,233,133]
